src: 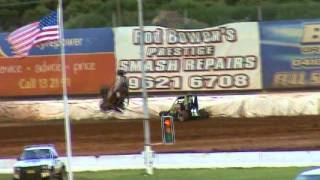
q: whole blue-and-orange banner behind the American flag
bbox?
[0,28,116,97]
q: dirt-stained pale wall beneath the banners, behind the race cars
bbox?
[0,93,320,121]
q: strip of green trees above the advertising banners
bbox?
[0,0,320,32]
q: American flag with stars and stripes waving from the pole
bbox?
[7,11,59,57]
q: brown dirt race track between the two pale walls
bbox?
[0,116,320,158]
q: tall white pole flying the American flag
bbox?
[58,0,73,180]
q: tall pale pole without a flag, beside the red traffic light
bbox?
[138,0,153,175]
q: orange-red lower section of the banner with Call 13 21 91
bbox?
[0,53,115,97]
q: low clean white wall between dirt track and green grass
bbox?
[0,151,320,173]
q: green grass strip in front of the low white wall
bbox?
[0,167,305,180]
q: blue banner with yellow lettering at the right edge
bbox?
[260,20,320,89]
